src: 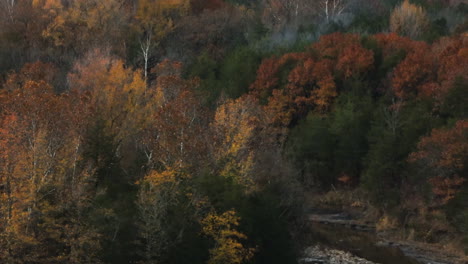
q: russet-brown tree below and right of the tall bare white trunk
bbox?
[140,60,211,171]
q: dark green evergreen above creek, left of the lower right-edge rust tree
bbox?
[362,97,435,207]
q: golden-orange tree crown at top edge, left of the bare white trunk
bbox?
[41,0,128,54]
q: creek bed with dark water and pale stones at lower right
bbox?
[300,212,468,264]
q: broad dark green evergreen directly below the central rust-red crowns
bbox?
[287,82,373,189]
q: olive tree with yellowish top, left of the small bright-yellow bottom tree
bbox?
[136,168,195,264]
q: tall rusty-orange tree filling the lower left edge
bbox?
[1,63,99,263]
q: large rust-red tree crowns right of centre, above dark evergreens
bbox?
[250,33,374,120]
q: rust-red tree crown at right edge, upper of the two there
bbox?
[373,33,468,100]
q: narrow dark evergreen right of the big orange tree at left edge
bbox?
[84,120,140,263]
